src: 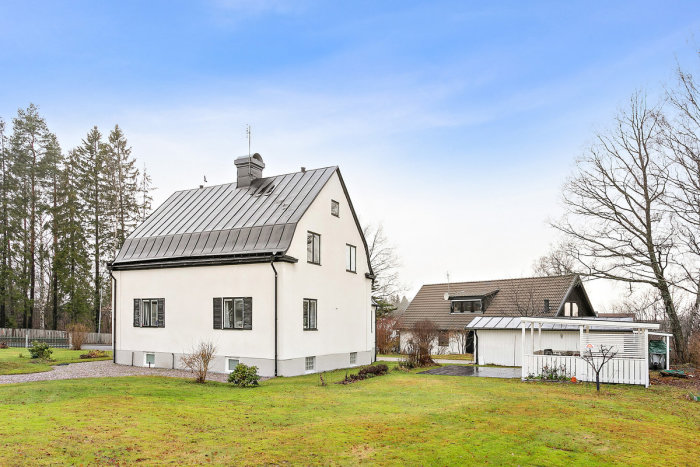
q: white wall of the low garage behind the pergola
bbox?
[477,329,579,366]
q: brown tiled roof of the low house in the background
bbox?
[400,274,593,330]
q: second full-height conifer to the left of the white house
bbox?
[76,127,113,329]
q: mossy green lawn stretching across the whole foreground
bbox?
[0,362,700,465]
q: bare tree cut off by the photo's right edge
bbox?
[664,69,700,314]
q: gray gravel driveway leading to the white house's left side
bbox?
[0,361,228,384]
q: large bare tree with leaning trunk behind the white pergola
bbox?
[554,94,686,358]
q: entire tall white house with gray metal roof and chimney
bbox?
[110,154,375,376]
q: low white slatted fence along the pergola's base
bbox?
[522,355,649,386]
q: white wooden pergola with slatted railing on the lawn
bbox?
[520,317,671,387]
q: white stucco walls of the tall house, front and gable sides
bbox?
[114,173,374,376]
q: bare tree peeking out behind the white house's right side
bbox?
[362,224,404,303]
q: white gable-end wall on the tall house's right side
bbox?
[279,173,374,374]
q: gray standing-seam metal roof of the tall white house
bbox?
[112,167,337,267]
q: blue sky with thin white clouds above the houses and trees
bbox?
[0,0,700,311]
